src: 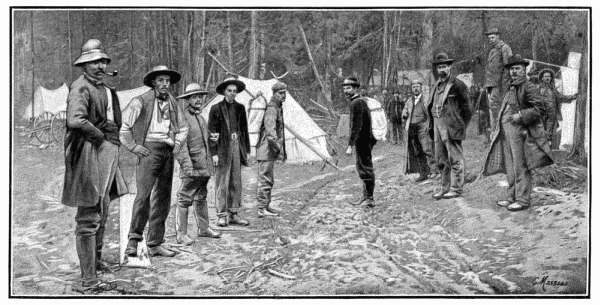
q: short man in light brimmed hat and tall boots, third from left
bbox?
[175,83,221,245]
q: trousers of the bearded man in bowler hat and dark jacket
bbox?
[433,118,465,193]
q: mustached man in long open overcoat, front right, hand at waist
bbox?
[483,54,553,211]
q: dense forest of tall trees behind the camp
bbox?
[12,9,589,156]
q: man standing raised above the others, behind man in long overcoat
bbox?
[483,28,512,137]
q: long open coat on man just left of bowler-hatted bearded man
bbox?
[402,93,433,174]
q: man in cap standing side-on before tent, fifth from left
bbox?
[256,82,287,217]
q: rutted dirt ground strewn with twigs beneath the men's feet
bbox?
[11,124,589,296]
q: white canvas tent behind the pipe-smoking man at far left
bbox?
[21,84,150,120]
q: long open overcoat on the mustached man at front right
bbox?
[483,79,554,176]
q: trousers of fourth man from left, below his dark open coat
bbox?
[216,139,242,218]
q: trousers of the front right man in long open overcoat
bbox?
[502,122,532,206]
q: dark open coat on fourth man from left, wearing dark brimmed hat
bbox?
[208,99,250,166]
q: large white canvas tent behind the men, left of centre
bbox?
[202,76,330,163]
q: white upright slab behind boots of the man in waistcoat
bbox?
[117,194,152,268]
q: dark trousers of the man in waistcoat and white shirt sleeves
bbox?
[129,142,174,247]
